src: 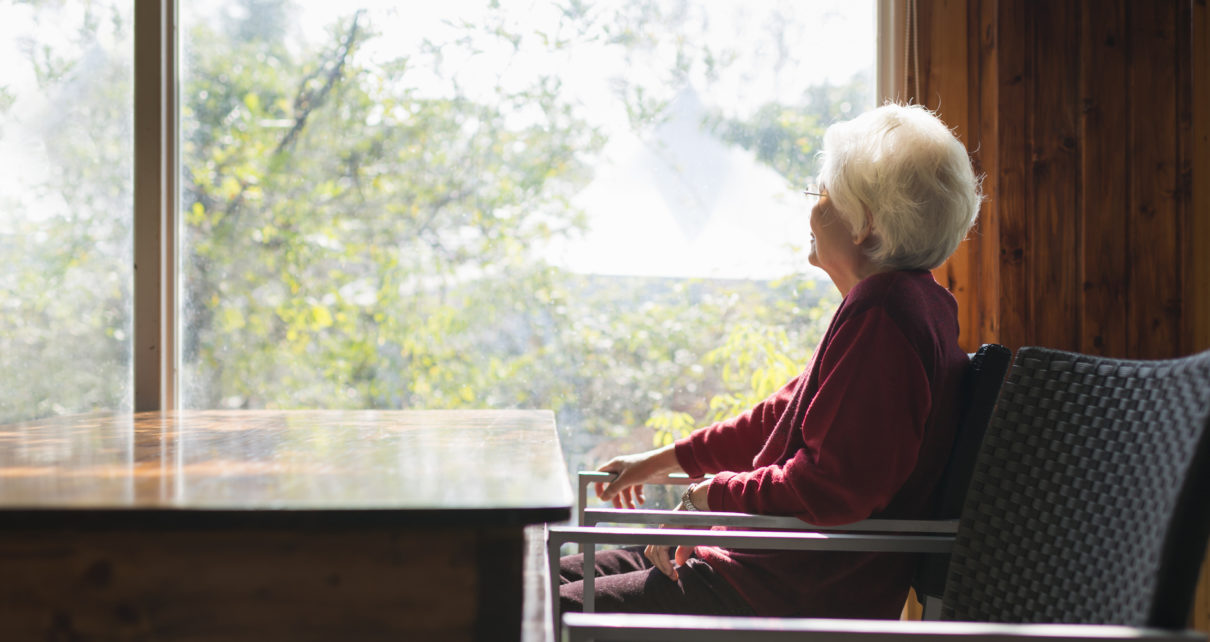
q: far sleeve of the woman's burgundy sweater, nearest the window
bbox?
[675,374,806,478]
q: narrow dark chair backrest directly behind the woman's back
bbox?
[912,343,1013,600]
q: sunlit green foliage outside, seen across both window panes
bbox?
[0,0,861,478]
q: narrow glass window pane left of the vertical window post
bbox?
[0,0,133,422]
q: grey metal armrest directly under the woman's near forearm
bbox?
[582,508,958,534]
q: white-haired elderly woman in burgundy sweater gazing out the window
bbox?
[560,104,981,618]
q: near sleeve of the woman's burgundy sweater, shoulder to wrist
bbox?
[707,308,932,526]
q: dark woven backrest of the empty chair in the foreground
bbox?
[941,348,1210,629]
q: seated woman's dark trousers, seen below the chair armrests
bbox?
[559,546,755,615]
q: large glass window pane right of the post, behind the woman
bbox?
[182,0,875,502]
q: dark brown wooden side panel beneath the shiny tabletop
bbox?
[0,530,523,641]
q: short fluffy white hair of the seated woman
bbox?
[819,104,983,270]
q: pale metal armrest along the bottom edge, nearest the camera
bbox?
[563,613,1206,642]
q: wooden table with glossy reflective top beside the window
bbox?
[0,411,571,641]
